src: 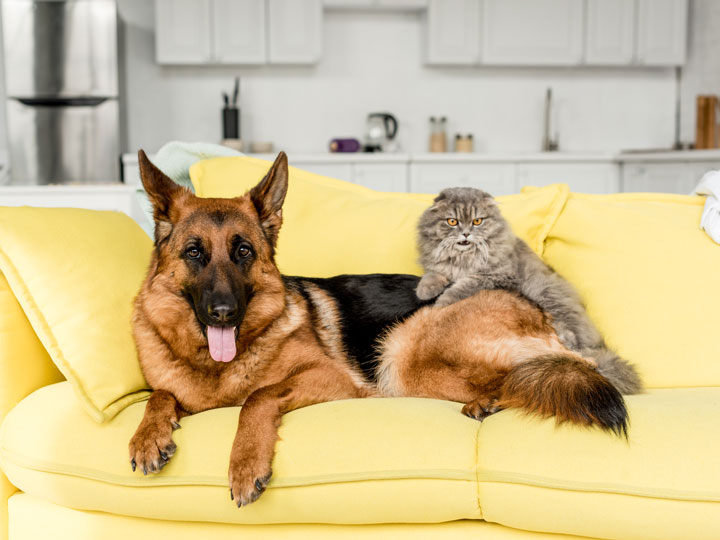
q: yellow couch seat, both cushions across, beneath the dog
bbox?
[0,382,720,539]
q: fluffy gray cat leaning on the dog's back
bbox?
[417,188,642,394]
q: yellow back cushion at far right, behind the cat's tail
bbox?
[545,193,720,388]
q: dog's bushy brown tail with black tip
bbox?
[496,355,628,439]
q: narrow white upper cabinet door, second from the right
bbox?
[585,0,636,66]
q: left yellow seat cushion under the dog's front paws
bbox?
[0,382,482,524]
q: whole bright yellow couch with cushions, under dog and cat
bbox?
[0,158,720,540]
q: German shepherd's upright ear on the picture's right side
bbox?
[250,152,288,247]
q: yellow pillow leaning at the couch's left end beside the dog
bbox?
[0,207,151,421]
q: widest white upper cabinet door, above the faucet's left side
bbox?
[482,0,584,65]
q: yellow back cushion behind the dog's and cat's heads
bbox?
[190,157,568,277]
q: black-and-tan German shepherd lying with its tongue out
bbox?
[129,150,627,507]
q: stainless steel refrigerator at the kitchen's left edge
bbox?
[1,0,120,184]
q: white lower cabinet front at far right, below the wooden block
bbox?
[622,162,718,195]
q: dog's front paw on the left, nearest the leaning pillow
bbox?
[129,421,180,475]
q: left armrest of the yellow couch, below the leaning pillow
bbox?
[0,273,64,540]
